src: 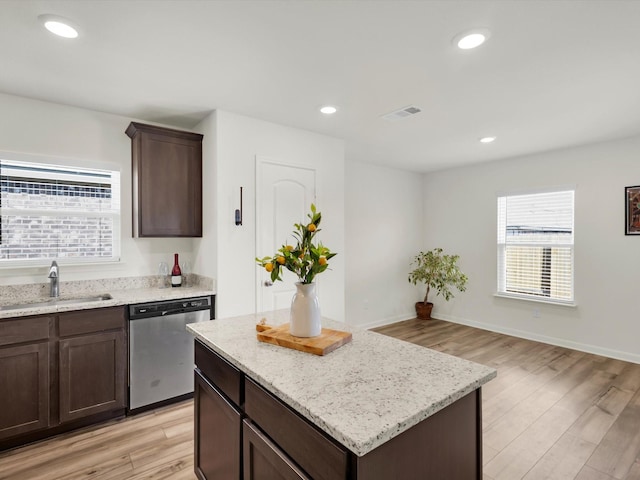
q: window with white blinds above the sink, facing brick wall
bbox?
[0,159,120,266]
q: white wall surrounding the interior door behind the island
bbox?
[198,111,346,320]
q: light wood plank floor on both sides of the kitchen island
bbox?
[0,320,640,480]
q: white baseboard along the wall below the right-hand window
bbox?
[434,314,640,364]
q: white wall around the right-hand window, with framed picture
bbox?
[424,138,640,363]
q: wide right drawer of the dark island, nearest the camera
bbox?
[245,378,349,480]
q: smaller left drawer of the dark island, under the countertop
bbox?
[195,340,244,406]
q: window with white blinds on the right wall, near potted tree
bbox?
[498,190,574,303]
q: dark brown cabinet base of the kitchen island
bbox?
[195,340,482,480]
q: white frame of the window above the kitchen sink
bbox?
[0,151,123,270]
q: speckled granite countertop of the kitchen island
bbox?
[187,310,496,456]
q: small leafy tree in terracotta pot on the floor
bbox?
[409,248,467,320]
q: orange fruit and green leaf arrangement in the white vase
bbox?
[256,204,337,284]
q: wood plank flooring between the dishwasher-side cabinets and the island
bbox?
[0,400,196,480]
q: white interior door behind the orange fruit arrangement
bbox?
[256,157,316,312]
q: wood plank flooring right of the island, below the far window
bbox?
[375,320,640,480]
